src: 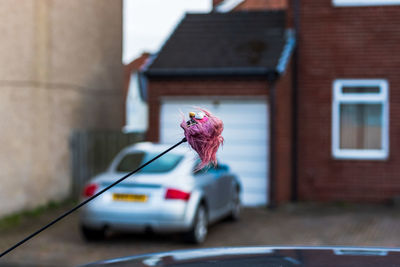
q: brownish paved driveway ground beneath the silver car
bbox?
[0,204,400,266]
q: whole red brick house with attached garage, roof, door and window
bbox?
[127,0,400,205]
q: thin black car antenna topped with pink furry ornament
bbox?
[0,108,224,258]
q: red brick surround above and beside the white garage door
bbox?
[147,75,291,203]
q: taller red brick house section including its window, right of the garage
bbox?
[289,0,400,202]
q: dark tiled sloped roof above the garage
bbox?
[147,11,286,76]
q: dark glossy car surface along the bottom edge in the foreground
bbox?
[79,247,400,267]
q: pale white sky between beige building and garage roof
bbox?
[122,0,212,64]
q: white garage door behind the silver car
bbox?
[160,98,269,206]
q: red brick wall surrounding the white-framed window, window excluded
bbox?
[298,0,400,202]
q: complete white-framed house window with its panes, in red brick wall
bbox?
[332,80,389,159]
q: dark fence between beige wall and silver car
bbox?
[70,130,144,198]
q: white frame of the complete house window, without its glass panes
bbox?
[332,79,389,160]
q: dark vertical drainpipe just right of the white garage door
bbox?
[267,72,279,209]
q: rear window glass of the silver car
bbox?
[117,152,183,173]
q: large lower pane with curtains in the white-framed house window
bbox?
[340,104,383,149]
